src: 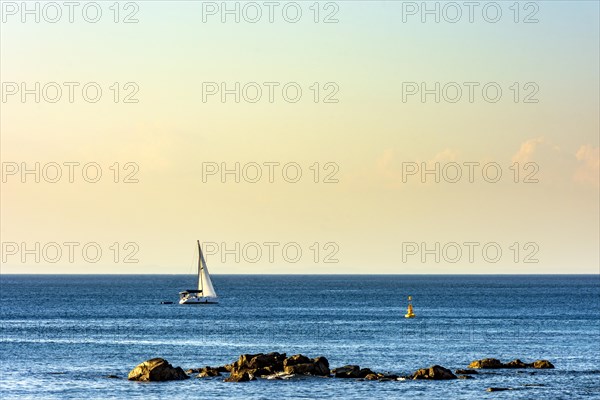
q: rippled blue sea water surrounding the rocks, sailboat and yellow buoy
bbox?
[0,275,600,399]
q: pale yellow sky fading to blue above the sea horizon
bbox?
[0,1,600,274]
